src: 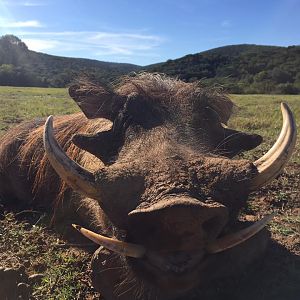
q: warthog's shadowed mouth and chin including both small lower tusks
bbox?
[73,214,274,292]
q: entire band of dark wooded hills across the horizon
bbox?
[0,35,300,94]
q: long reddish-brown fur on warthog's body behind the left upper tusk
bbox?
[0,113,111,213]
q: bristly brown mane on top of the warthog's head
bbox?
[115,73,234,124]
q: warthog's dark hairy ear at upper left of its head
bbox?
[69,82,125,120]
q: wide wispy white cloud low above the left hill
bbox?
[19,31,163,59]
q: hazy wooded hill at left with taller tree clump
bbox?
[0,35,140,87]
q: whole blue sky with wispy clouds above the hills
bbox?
[0,0,300,65]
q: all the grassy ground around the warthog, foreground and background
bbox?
[0,87,300,300]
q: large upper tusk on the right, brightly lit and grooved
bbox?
[250,103,297,191]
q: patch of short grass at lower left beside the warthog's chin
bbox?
[0,213,94,300]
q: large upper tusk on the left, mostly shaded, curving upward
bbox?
[43,116,99,199]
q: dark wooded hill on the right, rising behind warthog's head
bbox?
[147,45,300,94]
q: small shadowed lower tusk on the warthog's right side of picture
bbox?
[206,213,275,254]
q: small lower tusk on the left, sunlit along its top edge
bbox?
[72,224,146,258]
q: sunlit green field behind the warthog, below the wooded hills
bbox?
[0,87,300,163]
